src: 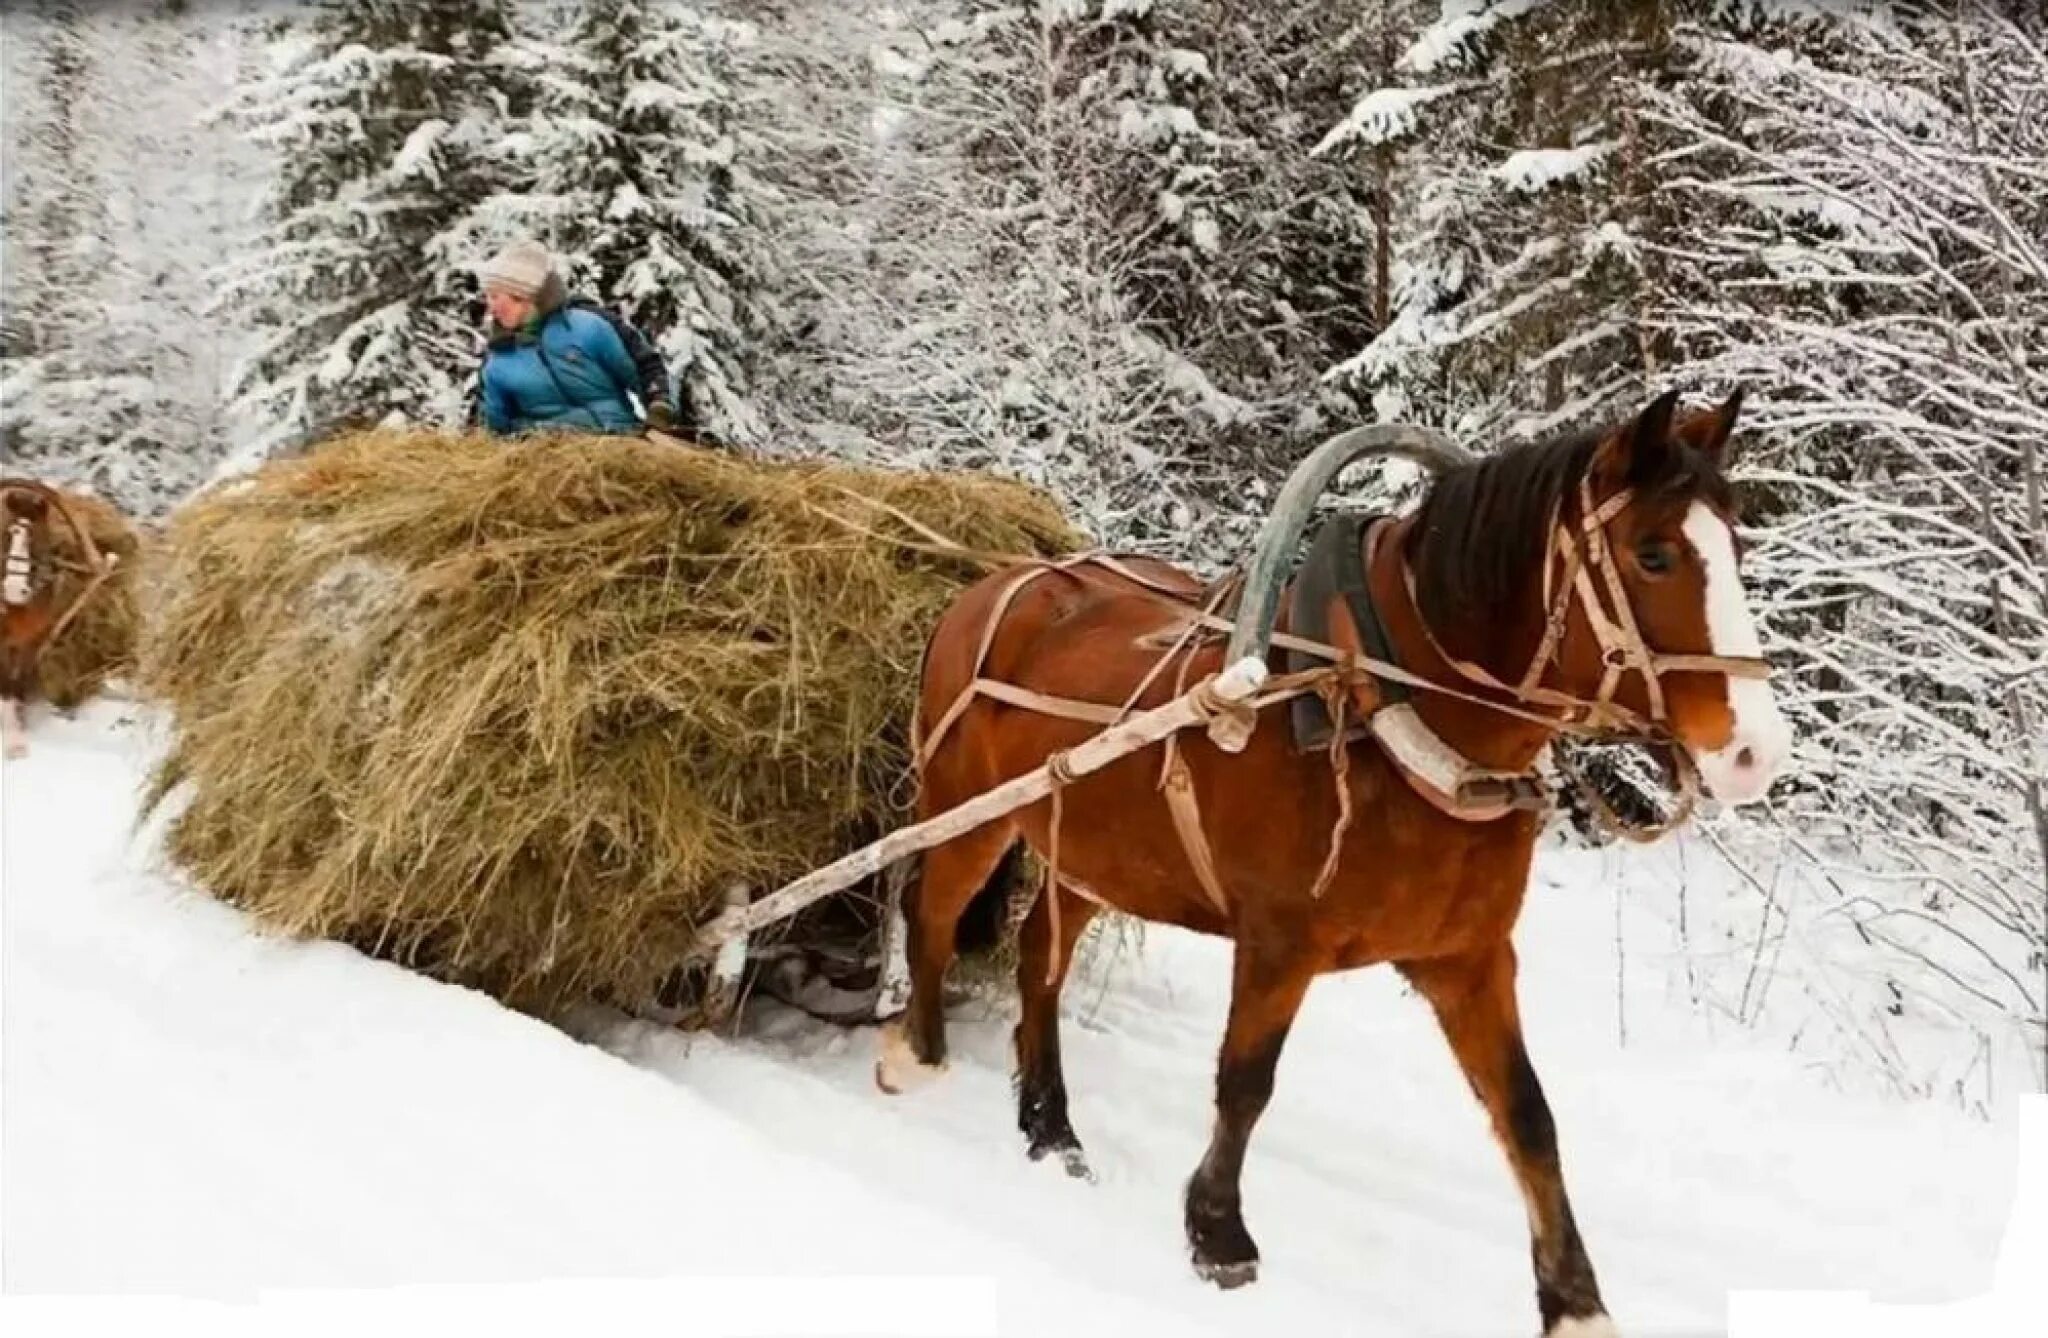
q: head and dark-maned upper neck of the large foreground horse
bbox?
[1411,391,1792,803]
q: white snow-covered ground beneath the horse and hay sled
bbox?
[0,705,2017,1336]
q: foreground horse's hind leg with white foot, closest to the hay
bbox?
[874,824,1016,1092]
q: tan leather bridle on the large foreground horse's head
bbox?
[1403,477,1772,744]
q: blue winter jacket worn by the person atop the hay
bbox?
[481,297,641,434]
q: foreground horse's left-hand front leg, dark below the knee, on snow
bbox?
[1186,938,1315,1287]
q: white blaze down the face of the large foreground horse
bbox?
[1683,502,1792,803]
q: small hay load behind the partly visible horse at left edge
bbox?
[12,484,145,711]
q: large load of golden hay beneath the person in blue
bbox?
[143,430,1083,1012]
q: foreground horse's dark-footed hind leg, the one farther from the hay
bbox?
[1014,879,1100,1180]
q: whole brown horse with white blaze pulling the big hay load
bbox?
[877,391,1790,1334]
